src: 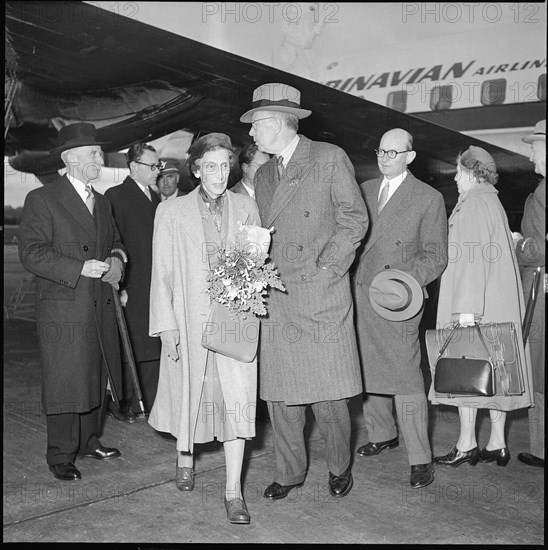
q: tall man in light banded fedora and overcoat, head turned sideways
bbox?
[240,83,368,499]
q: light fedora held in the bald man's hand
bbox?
[369,269,424,321]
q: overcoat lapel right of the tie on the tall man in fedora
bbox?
[266,136,311,227]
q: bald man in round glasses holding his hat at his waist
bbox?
[353,128,447,488]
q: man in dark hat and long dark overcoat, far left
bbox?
[19,123,127,481]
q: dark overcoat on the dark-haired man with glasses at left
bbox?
[105,176,161,362]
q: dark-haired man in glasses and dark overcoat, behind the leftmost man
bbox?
[105,143,163,423]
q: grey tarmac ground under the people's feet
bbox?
[3,246,544,547]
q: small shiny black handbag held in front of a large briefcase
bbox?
[434,325,495,397]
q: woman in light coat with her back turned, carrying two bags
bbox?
[429,146,532,467]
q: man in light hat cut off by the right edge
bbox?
[516,120,546,468]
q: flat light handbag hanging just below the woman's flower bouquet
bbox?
[202,300,260,363]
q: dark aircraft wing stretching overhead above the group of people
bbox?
[5,1,538,214]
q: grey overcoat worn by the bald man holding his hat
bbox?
[354,172,447,395]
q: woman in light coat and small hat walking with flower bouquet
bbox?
[149,134,260,523]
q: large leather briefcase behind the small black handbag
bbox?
[426,322,525,396]
